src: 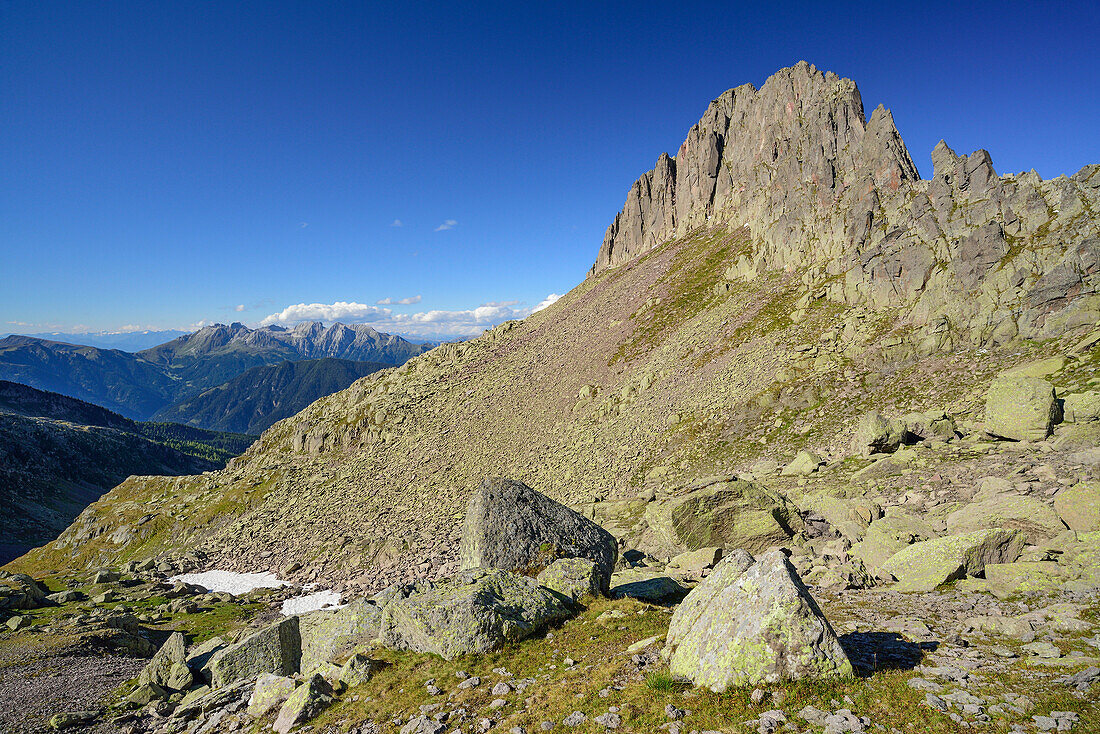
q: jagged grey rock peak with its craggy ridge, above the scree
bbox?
[590,62,1100,343]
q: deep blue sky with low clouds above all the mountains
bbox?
[0,0,1100,335]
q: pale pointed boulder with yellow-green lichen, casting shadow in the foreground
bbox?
[669,549,854,692]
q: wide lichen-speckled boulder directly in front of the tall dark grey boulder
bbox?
[381,569,571,660]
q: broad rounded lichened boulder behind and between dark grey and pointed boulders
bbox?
[645,476,803,555]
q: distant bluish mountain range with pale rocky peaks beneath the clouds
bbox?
[0,322,432,425]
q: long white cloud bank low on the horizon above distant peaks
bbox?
[260,294,560,338]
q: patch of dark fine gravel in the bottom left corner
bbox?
[0,656,149,734]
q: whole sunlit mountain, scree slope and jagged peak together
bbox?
[10,65,1100,588]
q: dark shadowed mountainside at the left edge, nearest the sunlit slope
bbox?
[0,380,255,563]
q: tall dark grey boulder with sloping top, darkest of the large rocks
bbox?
[460,476,618,592]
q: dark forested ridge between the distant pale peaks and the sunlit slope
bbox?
[154,358,393,435]
